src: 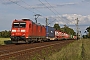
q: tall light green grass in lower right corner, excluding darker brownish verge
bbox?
[47,39,90,60]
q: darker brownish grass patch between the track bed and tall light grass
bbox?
[29,46,56,60]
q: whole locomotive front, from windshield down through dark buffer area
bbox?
[11,22,26,41]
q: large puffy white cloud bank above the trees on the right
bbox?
[45,14,90,25]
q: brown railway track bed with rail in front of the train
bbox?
[0,40,73,60]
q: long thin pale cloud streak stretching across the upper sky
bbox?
[25,3,77,9]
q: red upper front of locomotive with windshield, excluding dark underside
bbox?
[11,22,26,36]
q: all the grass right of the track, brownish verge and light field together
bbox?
[5,39,90,60]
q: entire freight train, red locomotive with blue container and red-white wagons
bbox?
[11,19,76,43]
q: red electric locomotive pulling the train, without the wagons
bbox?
[11,19,46,43]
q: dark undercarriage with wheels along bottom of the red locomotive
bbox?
[11,36,47,44]
